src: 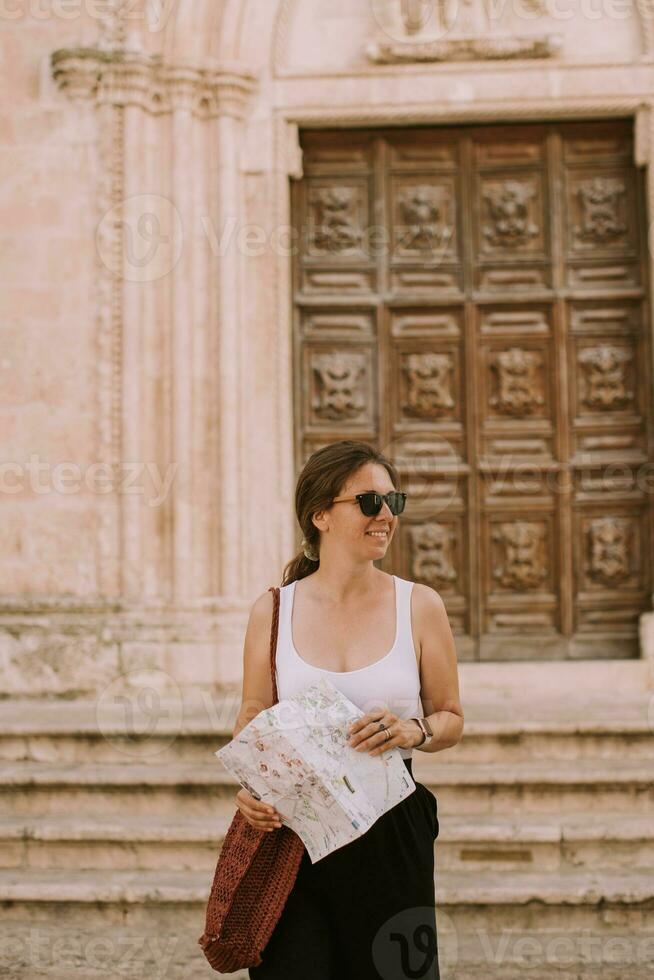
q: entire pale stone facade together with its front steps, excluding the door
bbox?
[0,9,654,980]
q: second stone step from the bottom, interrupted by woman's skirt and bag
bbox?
[0,801,654,874]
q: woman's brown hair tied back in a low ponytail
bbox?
[282,439,400,585]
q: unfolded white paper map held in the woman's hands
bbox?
[216,678,416,864]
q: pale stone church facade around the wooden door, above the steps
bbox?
[0,0,654,697]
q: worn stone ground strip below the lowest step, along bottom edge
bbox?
[0,928,652,980]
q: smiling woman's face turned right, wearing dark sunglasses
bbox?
[323,463,398,561]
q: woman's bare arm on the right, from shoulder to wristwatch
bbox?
[413,582,464,752]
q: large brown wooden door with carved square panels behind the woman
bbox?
[292,120,654,659]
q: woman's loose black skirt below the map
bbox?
[249,759,440,980]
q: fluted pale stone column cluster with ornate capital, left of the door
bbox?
[42,46,255,683]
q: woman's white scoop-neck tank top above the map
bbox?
[275,575,424,759]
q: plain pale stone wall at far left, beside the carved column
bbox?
[0,3,103,596]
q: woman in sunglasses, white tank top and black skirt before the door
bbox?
[234,440,463,980]
